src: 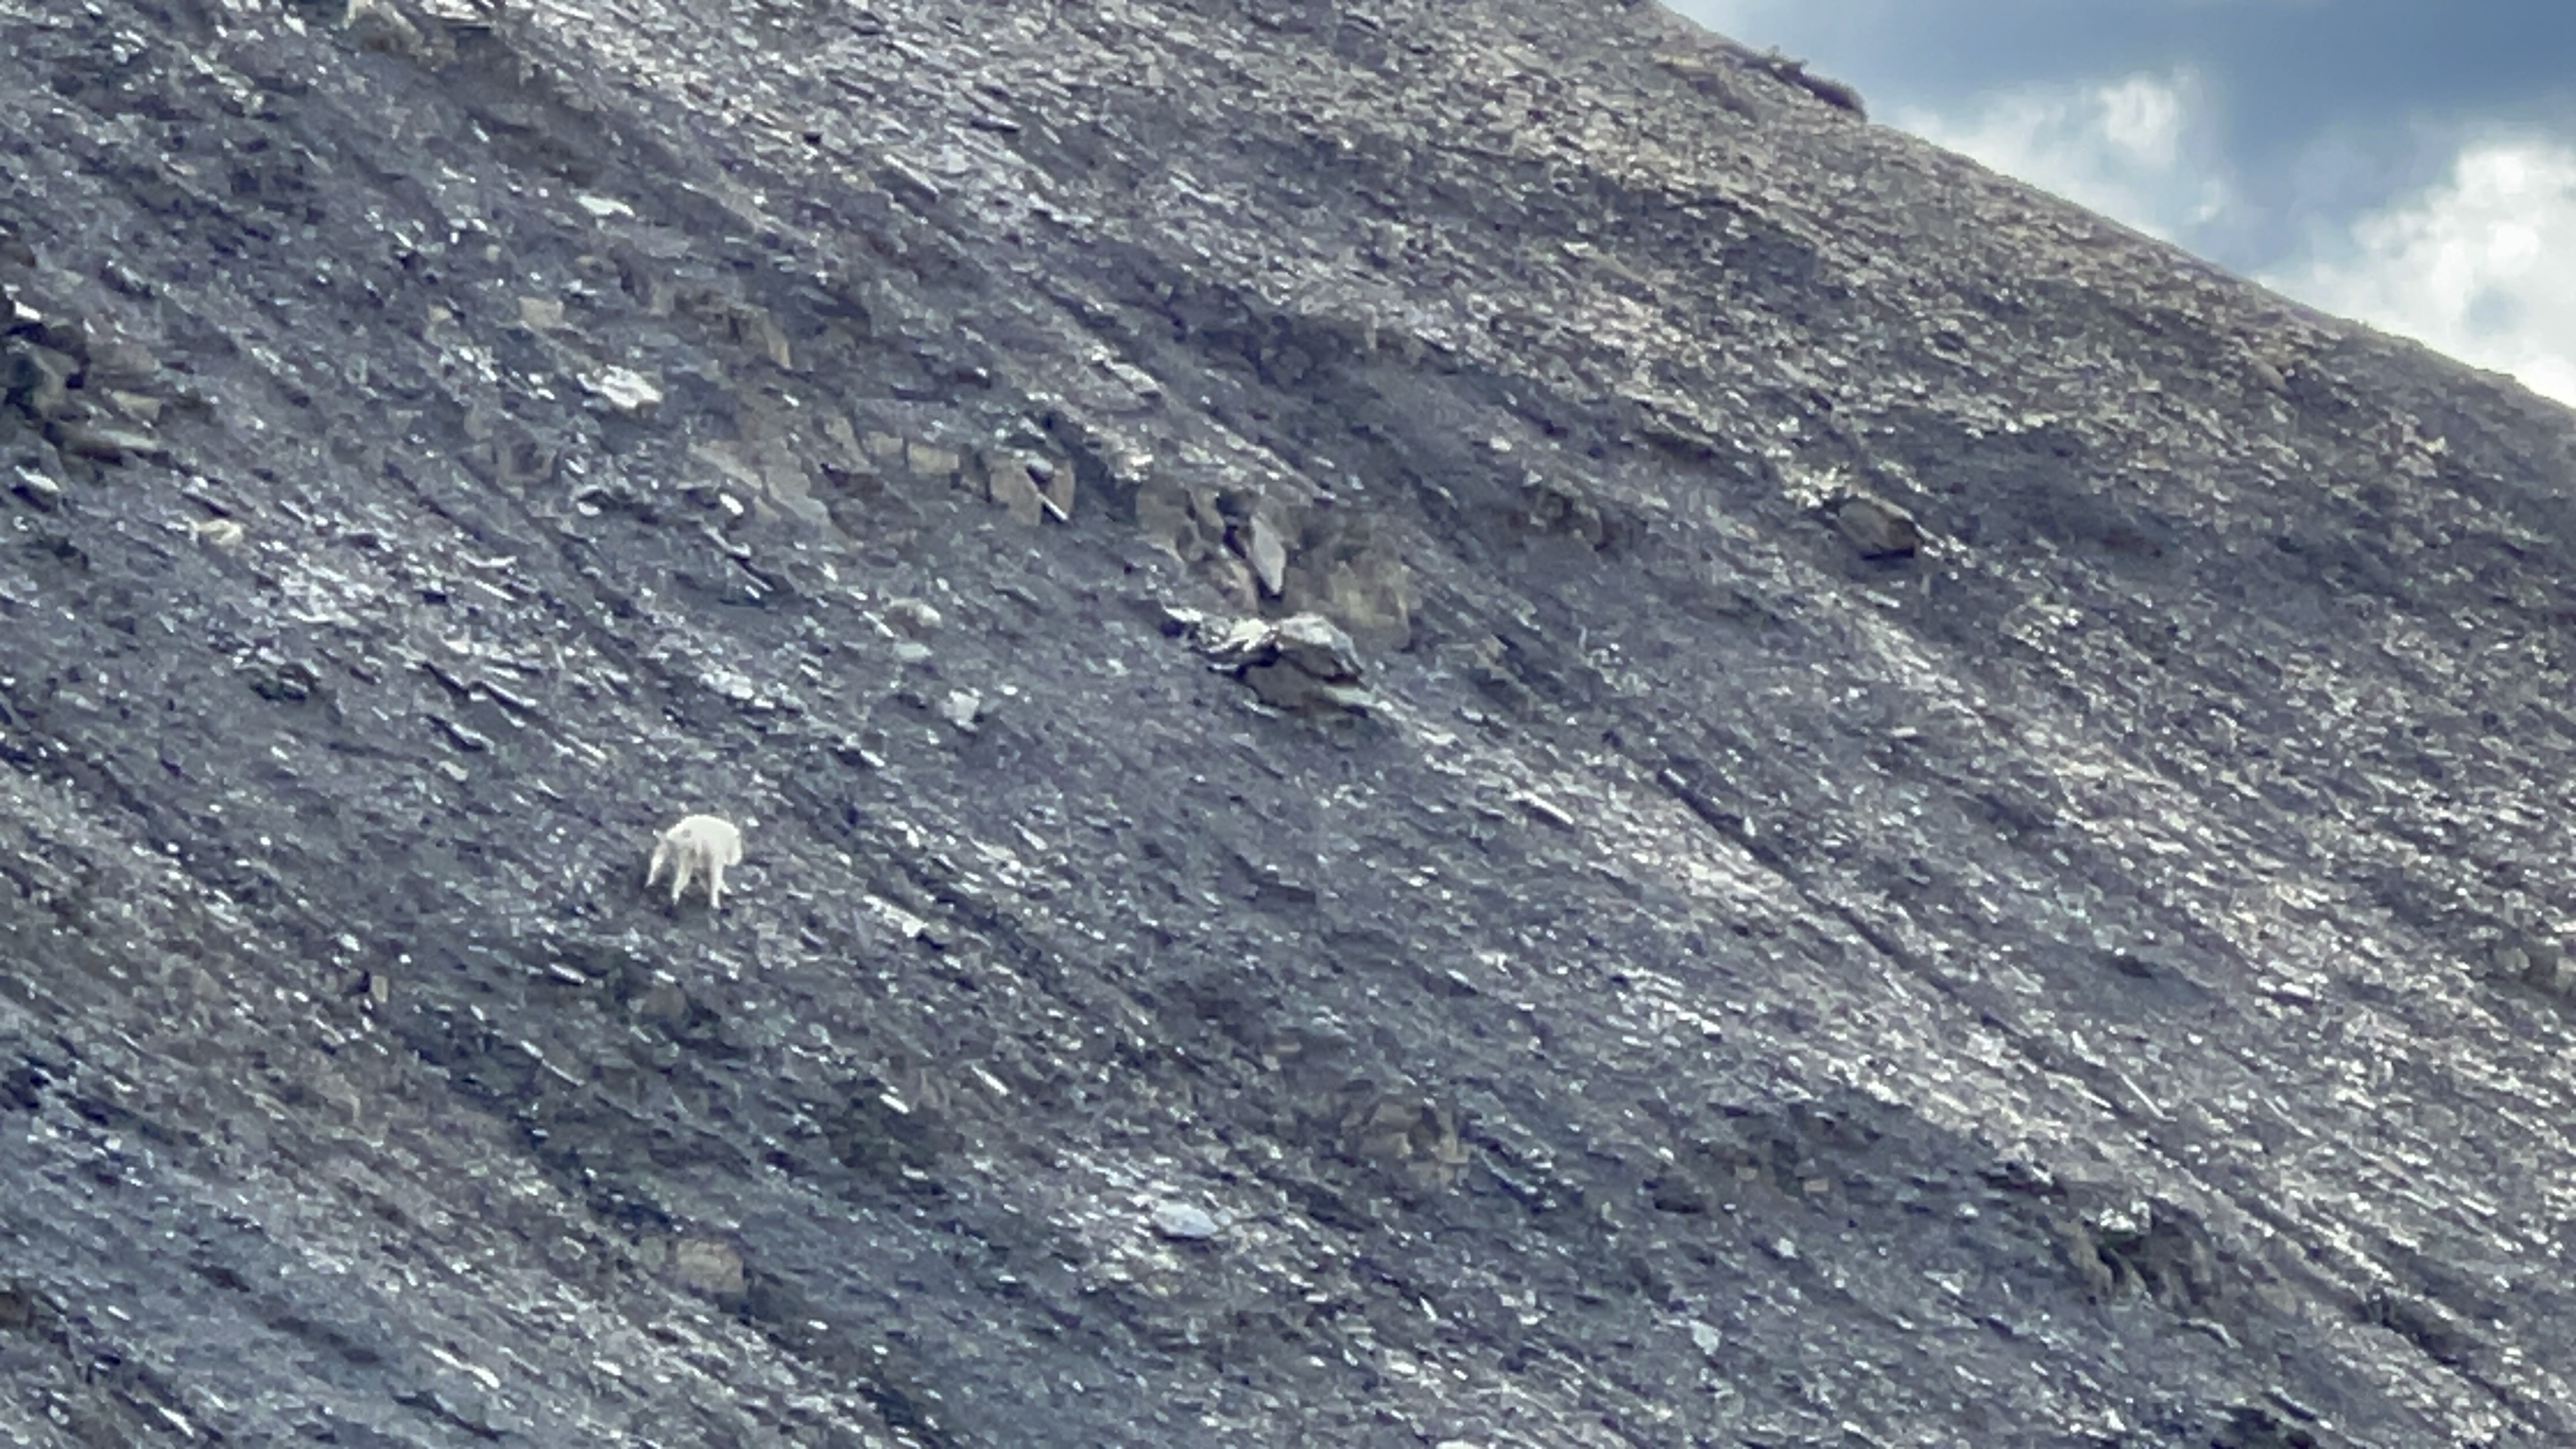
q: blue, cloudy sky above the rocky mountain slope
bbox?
[1666,0,2576,405]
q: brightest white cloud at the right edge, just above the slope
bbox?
[2264,137,2576,405]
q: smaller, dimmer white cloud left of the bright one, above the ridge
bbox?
[1893,70,2231,240]
